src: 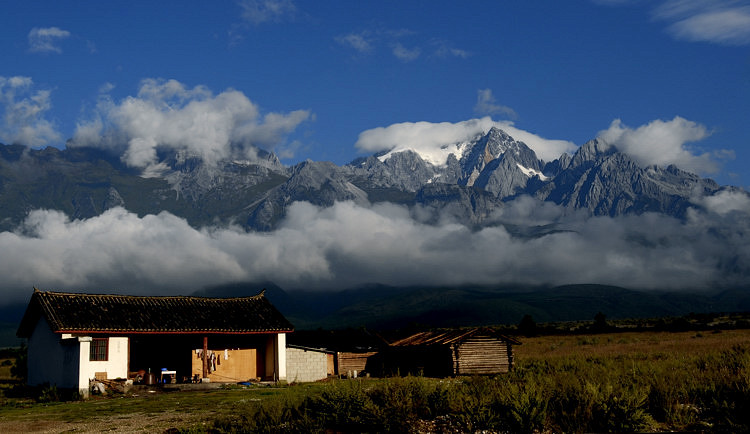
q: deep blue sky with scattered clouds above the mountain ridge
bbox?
[0,0,750,188]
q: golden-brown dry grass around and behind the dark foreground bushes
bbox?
[0,330,750,432]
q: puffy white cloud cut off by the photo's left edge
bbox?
[0,76,60,147]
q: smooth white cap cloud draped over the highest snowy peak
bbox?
[355,117,576,165]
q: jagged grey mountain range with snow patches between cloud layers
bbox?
[0,128,746,230]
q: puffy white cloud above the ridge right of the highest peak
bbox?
[598,116,726,174]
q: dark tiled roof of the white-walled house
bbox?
[17,289,294,337]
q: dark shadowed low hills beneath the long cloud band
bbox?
[0,282,750,348]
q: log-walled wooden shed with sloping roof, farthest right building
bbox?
[383,328,520,377]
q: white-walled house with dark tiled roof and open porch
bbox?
[17,288,294,395]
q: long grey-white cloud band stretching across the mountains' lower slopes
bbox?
[0,196,750,302]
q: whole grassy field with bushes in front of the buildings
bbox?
[0,330,750,432]
